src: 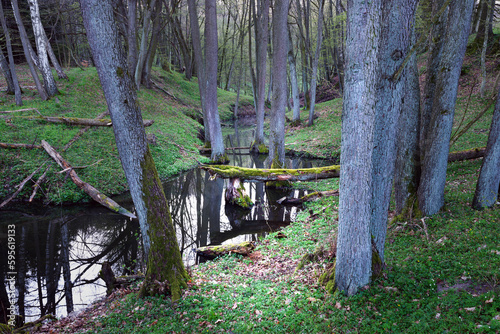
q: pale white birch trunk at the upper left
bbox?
[28,0,59,97]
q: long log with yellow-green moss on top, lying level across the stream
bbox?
[200,165,340,181]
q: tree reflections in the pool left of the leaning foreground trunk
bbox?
[0,210,141,325]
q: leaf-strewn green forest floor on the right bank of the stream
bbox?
[0,52,500,333]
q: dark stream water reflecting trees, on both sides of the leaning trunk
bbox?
[0,119,328,322]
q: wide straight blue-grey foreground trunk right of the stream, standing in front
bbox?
[335,0,382,295]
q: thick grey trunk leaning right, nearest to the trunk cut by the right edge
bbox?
[418,0,474,216]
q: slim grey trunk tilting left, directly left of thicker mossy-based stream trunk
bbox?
[188,0,210,145]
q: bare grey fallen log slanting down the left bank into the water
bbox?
[42,140,137,218]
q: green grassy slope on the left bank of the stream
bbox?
[0,67,249,203]
